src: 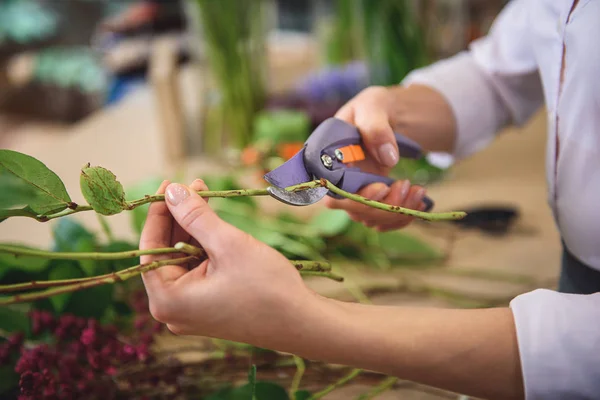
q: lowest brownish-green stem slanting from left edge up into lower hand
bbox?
[0,256,197,306]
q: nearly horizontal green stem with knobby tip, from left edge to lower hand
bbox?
[0,243,204,260]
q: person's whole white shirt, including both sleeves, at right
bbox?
[403,0,600,399]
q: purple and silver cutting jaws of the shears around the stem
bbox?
[264,149,329,206]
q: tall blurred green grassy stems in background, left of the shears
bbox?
[192,0,268,156]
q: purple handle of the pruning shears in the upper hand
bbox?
[304,118,434,211]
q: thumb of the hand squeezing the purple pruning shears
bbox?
[354,101,399,168]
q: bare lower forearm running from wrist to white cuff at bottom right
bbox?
[270,299,523,399]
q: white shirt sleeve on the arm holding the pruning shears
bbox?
[402,0,544,159]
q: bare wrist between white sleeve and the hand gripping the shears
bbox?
[388,84,456,153]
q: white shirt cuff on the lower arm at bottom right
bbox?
[510,289,600,400]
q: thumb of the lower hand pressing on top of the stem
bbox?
[165,183,235,256]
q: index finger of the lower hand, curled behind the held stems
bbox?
[140,181,186,290]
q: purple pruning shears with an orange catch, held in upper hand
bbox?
[264,118,434,211]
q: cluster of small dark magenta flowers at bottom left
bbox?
[0,292,169,400]
